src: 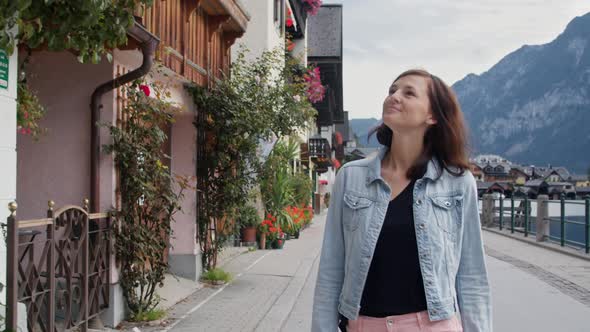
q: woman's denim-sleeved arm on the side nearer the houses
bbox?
[311,168,347,332]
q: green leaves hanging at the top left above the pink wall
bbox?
[0,0,153,63]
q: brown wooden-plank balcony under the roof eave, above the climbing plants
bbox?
[141,0,250,85]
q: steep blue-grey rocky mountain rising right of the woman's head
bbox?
[453,13,590,173]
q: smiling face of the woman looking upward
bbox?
[383,75,436,133]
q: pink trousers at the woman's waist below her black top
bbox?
[347,311,463,332]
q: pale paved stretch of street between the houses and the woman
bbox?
[141,213,325,332]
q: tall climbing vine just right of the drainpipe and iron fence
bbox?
[104,81,191,319]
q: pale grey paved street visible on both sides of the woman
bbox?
[134,214,590,332]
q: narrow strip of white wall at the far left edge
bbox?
[0,41,18,326]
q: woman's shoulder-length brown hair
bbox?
[369,69,469,179]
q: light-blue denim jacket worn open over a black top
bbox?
[312,148,492,332]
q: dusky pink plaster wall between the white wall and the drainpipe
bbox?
[17,52,113,219]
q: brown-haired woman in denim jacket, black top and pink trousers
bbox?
[312,70,492,332]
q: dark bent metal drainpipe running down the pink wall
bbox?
[90,22,160,212]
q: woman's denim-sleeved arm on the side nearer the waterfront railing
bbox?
[455,173,492,332]
